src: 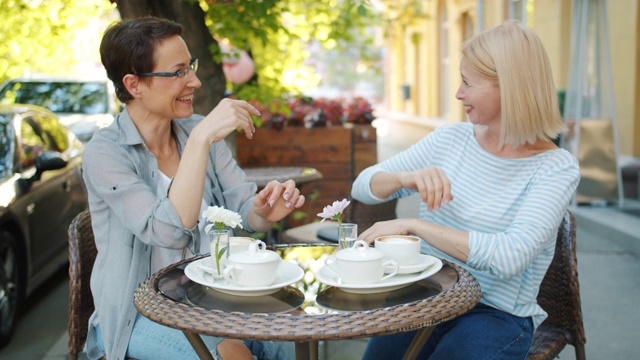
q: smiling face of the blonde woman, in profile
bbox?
[456,58,501,127]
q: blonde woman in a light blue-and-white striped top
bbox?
[352,21,579,360]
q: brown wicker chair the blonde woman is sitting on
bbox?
[528,211,586,360]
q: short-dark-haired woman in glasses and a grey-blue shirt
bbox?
[83,17,304,360]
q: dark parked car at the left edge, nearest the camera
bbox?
[0,104,87,347]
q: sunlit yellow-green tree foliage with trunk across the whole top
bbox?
[0,0,420,112]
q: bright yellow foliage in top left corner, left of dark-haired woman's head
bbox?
[0,0,111,81]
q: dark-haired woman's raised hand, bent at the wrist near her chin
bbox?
[200,99,260,143]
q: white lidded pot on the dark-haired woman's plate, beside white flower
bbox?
[223,240,282,287]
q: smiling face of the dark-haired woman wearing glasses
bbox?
[138,36,202,119]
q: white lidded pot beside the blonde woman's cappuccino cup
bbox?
[325,240,398,284]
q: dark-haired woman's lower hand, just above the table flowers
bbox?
[253,180,305,222]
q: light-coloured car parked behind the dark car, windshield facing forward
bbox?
[0,78,121,142]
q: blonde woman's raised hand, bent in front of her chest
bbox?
[398,166,453,210]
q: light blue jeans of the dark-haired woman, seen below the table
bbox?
[96,314,295,360]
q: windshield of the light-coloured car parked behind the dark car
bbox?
[0,81,109,114]
